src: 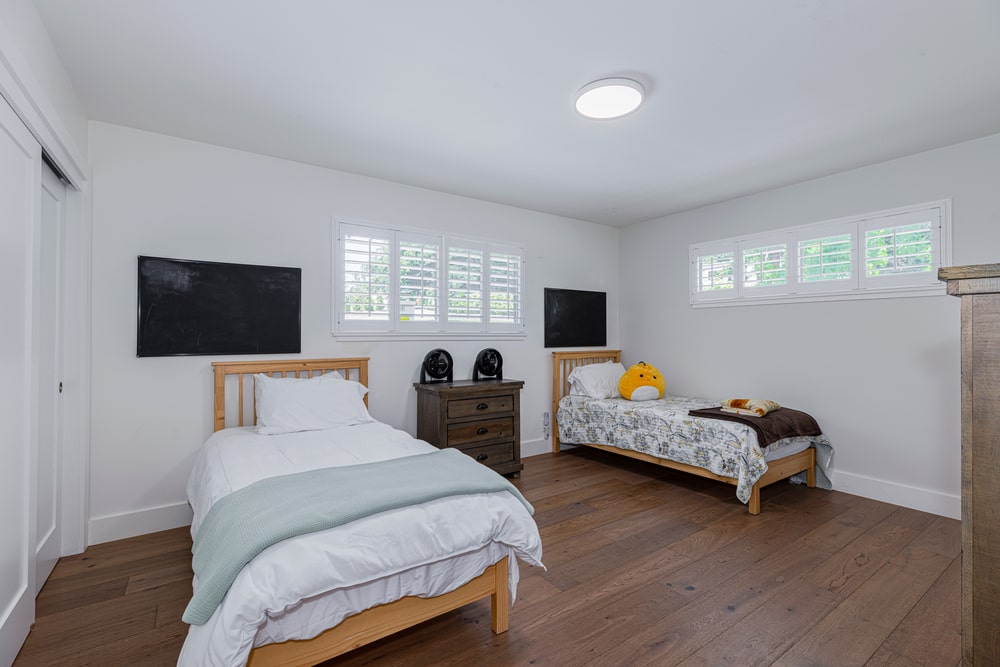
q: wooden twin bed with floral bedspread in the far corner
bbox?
[552,350,832,514]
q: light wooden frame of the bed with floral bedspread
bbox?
[552,350,816,515]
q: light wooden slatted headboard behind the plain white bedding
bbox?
[212,357,368,431]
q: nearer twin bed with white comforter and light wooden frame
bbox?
[178,358,541,667]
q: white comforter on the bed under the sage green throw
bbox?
[178,422,542,667]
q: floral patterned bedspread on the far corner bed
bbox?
[557,395,832,503]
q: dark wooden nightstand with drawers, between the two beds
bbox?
[413,380,524,476]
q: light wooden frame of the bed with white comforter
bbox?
[212,357,510,667]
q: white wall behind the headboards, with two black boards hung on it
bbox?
[90,122,618,543]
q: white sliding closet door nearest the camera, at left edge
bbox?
[0,98,41,665]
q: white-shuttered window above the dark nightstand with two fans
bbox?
[333,221,524,338]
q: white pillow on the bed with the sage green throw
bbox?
[254,372,375,435]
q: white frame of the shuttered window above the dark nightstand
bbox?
[330,217,527,340]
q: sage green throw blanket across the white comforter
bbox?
[183,449,534,625]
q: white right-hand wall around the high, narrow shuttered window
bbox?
[620,130,1000,518]
